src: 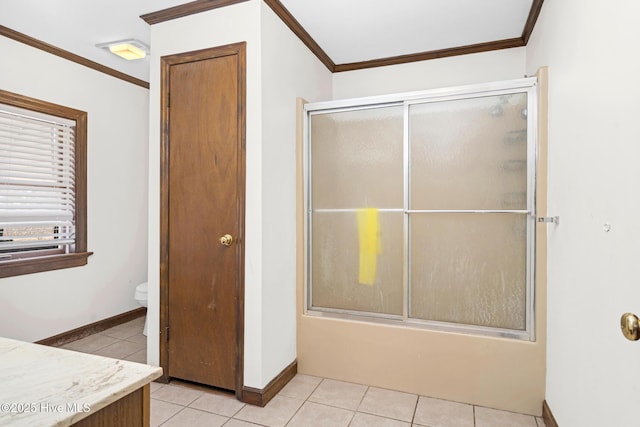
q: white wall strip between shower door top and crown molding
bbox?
[333,47,526,99]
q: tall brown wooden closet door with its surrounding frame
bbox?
[160,43,244,393]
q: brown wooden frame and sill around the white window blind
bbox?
[0,90,93,278]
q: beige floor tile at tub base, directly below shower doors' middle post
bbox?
[358,387,418,422]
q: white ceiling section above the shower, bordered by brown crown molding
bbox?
[281,0,532,64]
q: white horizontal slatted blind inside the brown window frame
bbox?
[0,104,75,254]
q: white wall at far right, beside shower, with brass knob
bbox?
[527,0,640,427]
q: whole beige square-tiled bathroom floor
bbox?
[62,318,544,427]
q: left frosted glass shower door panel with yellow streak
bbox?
[309,106,404,317]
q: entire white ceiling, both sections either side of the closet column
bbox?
[0,0,533,81]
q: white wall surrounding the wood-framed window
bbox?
[0,37,149,341]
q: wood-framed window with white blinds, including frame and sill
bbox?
[0,90,91,277]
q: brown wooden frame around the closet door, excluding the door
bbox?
[160,42,246,400]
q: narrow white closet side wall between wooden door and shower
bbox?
[260,2,332,385]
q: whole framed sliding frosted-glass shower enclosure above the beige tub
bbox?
[305,79,537,340]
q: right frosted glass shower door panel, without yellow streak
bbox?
[408,93,532,331]
